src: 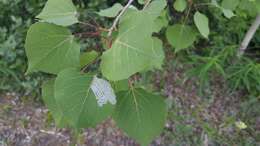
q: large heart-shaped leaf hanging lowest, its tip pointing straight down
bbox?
[113,89,167,146]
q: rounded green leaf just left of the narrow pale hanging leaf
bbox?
[166,24,196,52]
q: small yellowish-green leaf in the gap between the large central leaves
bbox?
[80,51,99,68]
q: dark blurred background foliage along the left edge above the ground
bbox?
[0,0,45,94]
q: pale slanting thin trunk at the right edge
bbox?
[238,14,260,56]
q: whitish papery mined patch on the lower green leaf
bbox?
[90,76,116,107]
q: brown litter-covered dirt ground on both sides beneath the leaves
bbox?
[0,63,252,146]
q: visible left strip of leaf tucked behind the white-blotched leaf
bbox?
[42,79,67,128]
